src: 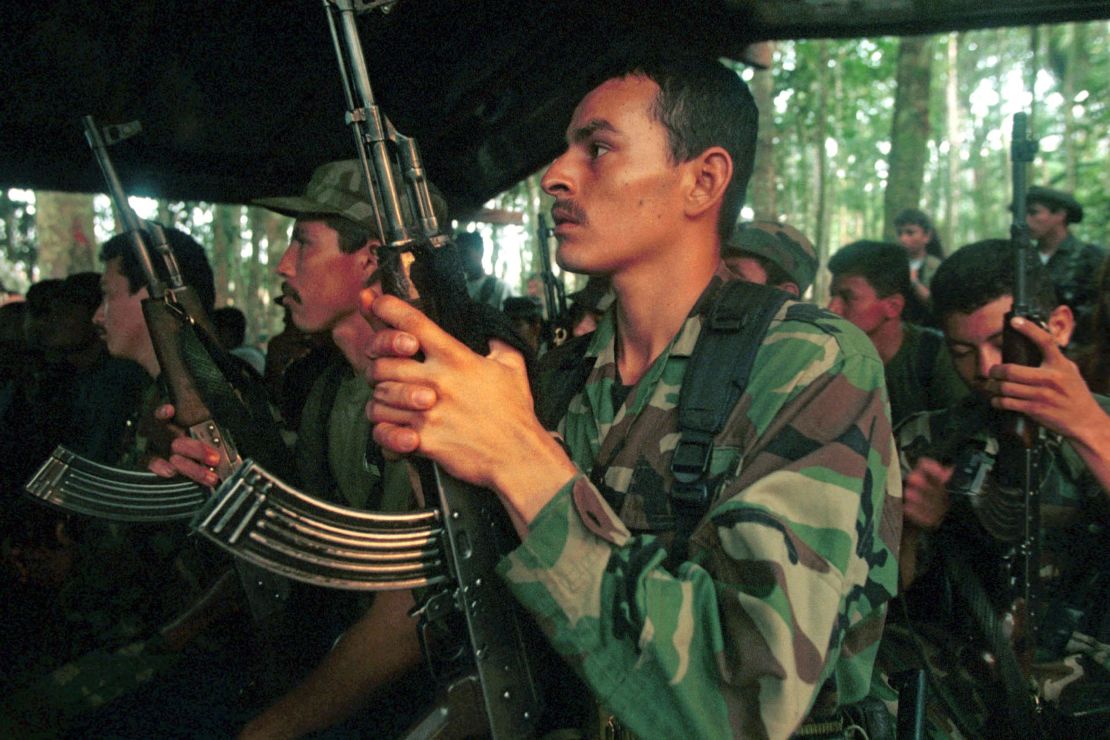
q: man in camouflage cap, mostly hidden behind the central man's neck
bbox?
[720,221,817,298]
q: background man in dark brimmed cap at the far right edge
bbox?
[1026,185,1106,345]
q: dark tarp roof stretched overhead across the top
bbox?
[0,0,1110,217]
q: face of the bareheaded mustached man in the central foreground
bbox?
[543,77,683,274]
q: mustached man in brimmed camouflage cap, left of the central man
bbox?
[136,160,430,738]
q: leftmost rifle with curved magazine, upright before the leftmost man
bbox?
[27,115,289,619]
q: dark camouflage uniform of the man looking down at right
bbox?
[880,396,1110,737]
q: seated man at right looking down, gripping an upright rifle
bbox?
[882,240,1110,737]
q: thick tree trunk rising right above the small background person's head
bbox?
[882,36,932,240]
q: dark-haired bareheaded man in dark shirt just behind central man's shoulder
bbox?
[829,242,967,426]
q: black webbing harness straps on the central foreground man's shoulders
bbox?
[536,280,790,565]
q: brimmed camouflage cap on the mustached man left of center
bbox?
[251,160,447,234]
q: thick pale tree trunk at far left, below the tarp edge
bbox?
[34,191,97,280]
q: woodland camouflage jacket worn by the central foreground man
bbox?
[498,271,901,738]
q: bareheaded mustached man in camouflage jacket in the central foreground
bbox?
[367,58,901,737]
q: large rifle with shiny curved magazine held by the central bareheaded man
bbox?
[198,0,539,738]
